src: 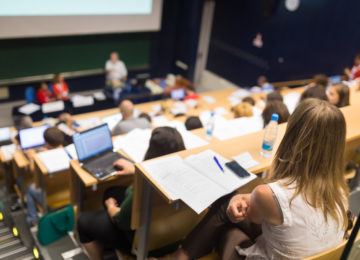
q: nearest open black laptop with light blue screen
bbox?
[73,124,126,180]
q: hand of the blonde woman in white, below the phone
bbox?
[226,194,250,223]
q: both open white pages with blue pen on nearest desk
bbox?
[141,150,256,214]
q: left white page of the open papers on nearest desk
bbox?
[141,156,225,214]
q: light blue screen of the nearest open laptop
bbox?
[73,124,113,161]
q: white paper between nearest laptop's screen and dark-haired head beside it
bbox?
[114,128,151,163]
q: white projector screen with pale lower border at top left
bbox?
[0,0,162,39]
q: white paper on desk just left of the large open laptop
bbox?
[38,148,70,173]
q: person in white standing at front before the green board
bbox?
[105,52,128,100]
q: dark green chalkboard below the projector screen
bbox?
[0,33,151,80]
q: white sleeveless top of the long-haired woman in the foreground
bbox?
[236,182,344,260]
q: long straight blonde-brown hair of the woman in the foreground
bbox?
[269,98,349,229]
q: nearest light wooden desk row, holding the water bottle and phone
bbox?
[132,89,360,259]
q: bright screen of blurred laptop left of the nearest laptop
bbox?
[19,125,50,149]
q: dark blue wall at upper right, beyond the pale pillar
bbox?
[207,0,360,86]
